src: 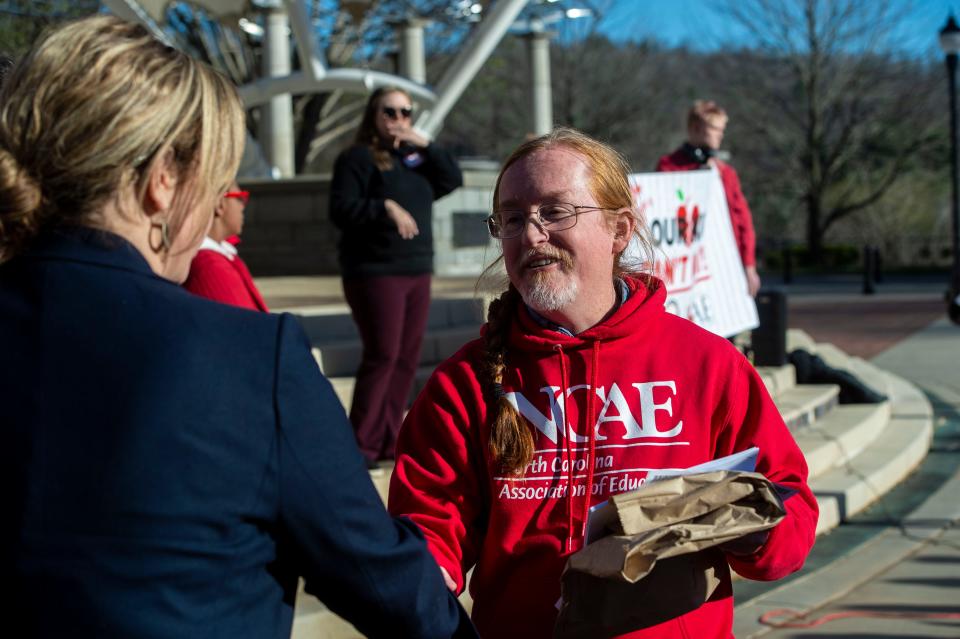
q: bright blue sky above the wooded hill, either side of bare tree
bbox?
[601,0,960,56]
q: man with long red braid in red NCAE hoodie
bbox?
[389,129,818,639]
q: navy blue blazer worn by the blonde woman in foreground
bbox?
[0,229,472,639]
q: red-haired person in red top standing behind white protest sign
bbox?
[657,100,760,297]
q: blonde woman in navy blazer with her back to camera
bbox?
[0,16,472,639]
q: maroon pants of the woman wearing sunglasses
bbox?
[343,274,430,461]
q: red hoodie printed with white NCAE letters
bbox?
[389,278,817,639]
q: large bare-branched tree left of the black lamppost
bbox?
[718,0,946,256]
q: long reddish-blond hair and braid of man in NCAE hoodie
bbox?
[478,127,653,474]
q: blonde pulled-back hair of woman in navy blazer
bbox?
[0,15,245,262]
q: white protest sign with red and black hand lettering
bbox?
[626,169,759,337]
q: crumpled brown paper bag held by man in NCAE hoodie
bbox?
[554,471,786,638]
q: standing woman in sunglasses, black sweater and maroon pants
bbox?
[330,87,463,466]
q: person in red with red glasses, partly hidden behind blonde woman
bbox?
[183,182,268,311]
